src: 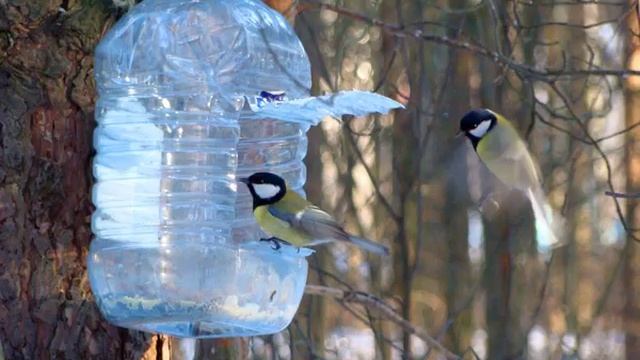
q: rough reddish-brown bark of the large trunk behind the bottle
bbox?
[0,0,260,359]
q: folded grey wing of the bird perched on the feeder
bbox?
[269,206,349,241]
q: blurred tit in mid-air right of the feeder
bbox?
[460,109,562,247]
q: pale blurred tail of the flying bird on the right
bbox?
[527,189,566,251]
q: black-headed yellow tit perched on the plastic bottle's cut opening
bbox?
[239,172,389,255]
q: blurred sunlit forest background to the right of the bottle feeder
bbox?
[286,0,640,359]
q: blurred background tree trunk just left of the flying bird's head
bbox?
[442,0,481,354]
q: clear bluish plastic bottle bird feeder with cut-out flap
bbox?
[88,0,401,337]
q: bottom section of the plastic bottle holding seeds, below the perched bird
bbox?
[89,239,307,338]
